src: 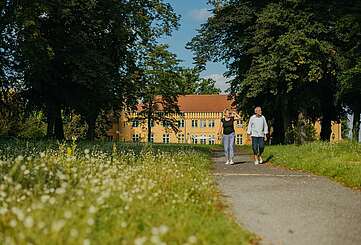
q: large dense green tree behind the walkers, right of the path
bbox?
[188,0,349,143]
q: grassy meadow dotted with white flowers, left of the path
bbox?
[0,141,254,245]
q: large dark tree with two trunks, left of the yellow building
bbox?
[13,0,178,139]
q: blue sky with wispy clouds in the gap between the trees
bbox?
[161,0,227,90]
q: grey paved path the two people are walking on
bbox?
[214,147,361,245]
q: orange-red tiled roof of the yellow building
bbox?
[138,94,234,112]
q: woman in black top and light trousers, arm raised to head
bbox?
[218,109,241,165]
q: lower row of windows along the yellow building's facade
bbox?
[132,134,243,145]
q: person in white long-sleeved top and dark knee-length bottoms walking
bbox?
[247,106,268,165]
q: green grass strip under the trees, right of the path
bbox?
[265,142,361,189]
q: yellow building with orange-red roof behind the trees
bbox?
[108,95,341,145]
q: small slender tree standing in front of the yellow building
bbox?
[137,45,184,142]
